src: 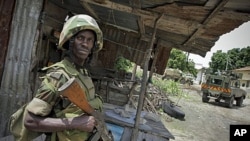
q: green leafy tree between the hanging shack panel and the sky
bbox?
[167,48,197,76]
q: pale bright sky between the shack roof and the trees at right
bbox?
[189,21,250,67]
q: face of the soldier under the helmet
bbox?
[73,30,95,60]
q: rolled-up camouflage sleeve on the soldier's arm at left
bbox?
[27,71,67,116]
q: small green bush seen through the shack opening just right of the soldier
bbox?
[114,56,132,71]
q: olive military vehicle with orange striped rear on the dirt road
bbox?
[201,72,246,108]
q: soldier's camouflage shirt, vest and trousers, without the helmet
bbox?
[27,59,102,141]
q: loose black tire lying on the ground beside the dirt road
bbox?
[162,101,185,120]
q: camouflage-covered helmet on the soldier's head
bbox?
[58,14,103,52]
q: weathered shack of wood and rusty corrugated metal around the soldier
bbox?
[0,0,250,139]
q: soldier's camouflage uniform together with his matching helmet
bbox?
[27,15,103,141]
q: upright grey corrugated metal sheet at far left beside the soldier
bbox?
[0,0,43,135]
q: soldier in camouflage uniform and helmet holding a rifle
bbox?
[24,14,103,141]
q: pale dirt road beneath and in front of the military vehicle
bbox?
[164,85,250,141]
